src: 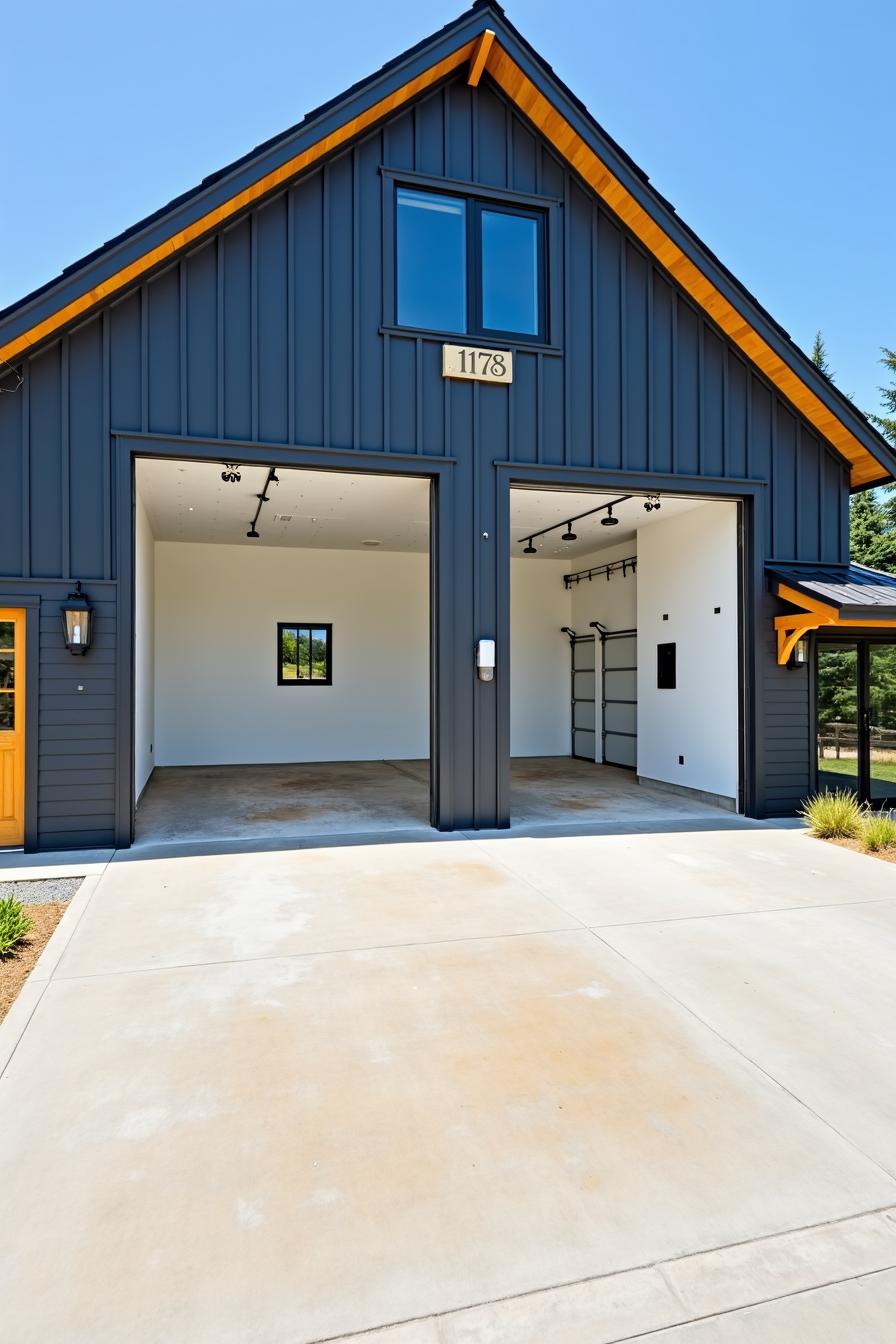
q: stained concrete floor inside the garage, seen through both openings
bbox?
[136,757,724,845]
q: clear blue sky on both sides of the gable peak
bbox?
[0,0,896,410]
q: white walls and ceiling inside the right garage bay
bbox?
[510,489,739,805]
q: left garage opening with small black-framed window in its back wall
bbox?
[134,458,430,844]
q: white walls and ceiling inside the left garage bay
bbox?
[136,461,430,792]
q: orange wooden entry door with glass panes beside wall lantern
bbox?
[0,606,26,845]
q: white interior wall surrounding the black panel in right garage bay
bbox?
[638,503,739,804]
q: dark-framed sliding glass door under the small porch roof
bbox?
[815,638,896,808]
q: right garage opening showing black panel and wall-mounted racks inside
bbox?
[510,487,742,825]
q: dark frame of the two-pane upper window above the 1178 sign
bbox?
[394,172,556,345]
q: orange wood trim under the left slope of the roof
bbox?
[0,42,476,362]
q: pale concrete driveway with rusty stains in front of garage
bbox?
[0,818,896,1344]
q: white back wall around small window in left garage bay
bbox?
[156,542,430,765]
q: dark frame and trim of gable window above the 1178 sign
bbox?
[380,167,553,349]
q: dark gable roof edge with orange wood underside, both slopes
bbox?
[0,0,896,489]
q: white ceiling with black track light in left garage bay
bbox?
[137,458,430,552]
